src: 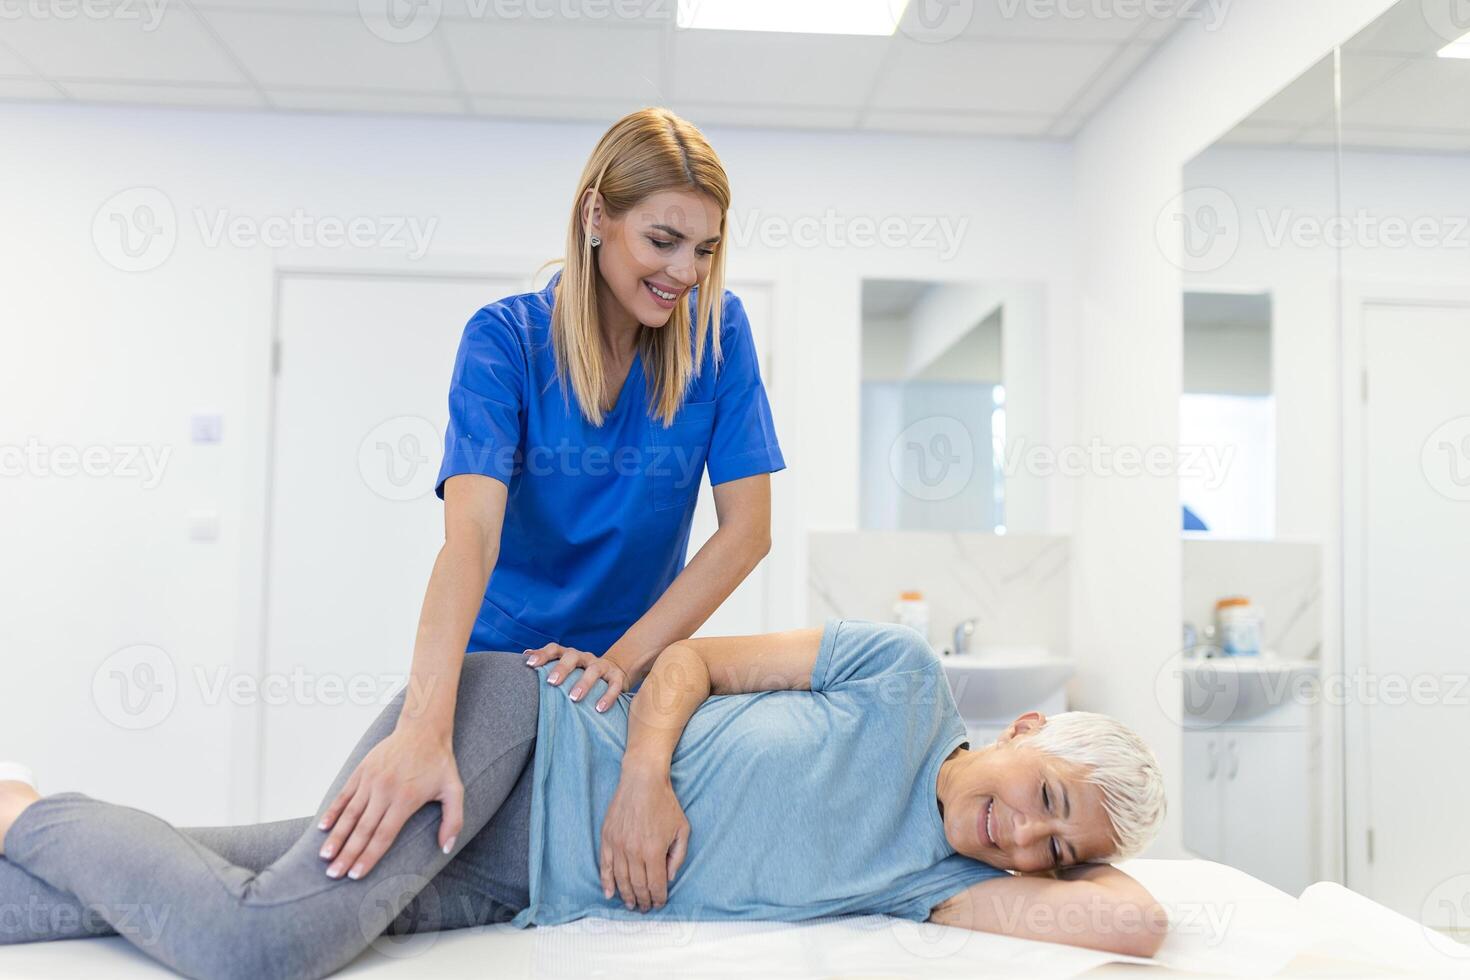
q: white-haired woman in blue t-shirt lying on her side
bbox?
[0,620,1167,977]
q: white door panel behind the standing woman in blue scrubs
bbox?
[259,275,773,820]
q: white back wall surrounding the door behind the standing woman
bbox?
[0,104,1073,823]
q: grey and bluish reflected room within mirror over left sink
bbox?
[860,279,1007,533]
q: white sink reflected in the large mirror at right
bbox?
[1179,657,1317,726]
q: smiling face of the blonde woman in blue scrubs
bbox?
[592,190,720,326]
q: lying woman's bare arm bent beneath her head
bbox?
[929,864,1169,956]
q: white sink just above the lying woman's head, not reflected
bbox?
[942,646,1076,726]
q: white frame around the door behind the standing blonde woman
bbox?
[228,250,806,823]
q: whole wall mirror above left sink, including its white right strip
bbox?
[858,279,1045,535]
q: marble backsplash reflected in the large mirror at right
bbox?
[1182,539,1322,660]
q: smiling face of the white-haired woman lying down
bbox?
[939,711,1116,871]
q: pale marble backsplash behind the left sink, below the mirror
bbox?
[807,530,1072,655]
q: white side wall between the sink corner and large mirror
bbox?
[1063,0,1391,857]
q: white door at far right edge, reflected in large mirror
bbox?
[1361,306,1470,926]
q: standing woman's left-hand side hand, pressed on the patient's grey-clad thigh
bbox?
[318,729,465,879]
